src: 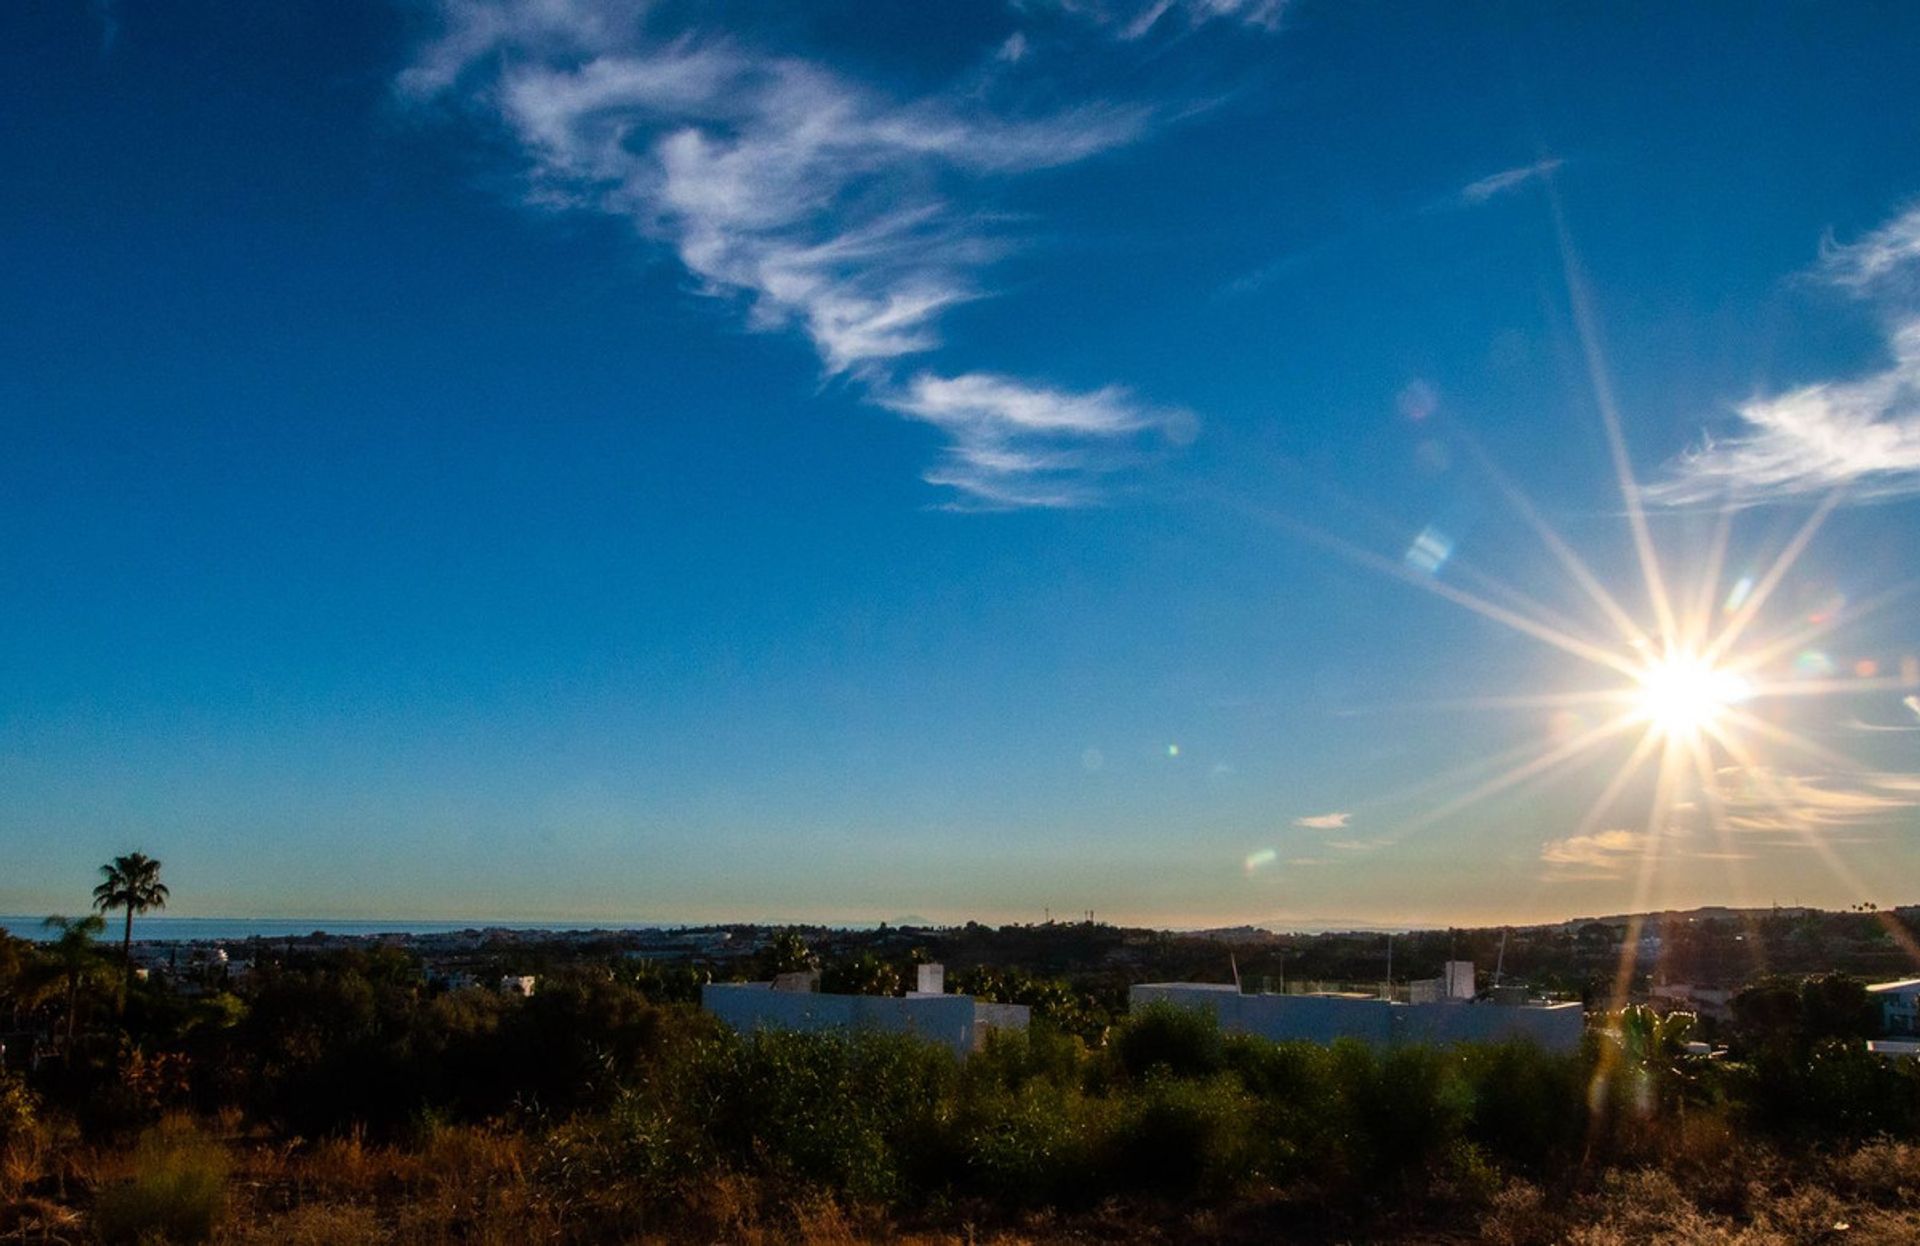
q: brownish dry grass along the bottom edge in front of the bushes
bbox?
[11,1119,1920,1246]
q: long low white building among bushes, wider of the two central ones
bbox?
[1127,979,1586,1052]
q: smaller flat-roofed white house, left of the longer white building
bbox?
[701,966,1029,1056]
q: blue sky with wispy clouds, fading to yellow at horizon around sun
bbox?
[0,0,1920,925]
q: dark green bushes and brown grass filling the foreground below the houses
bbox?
[0,871,1920,1244]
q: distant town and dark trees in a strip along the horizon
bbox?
[93,904,1920,1033]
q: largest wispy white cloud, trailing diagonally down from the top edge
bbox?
[397,0,1190,507]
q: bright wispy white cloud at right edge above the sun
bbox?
[1647,207,1920,505]
